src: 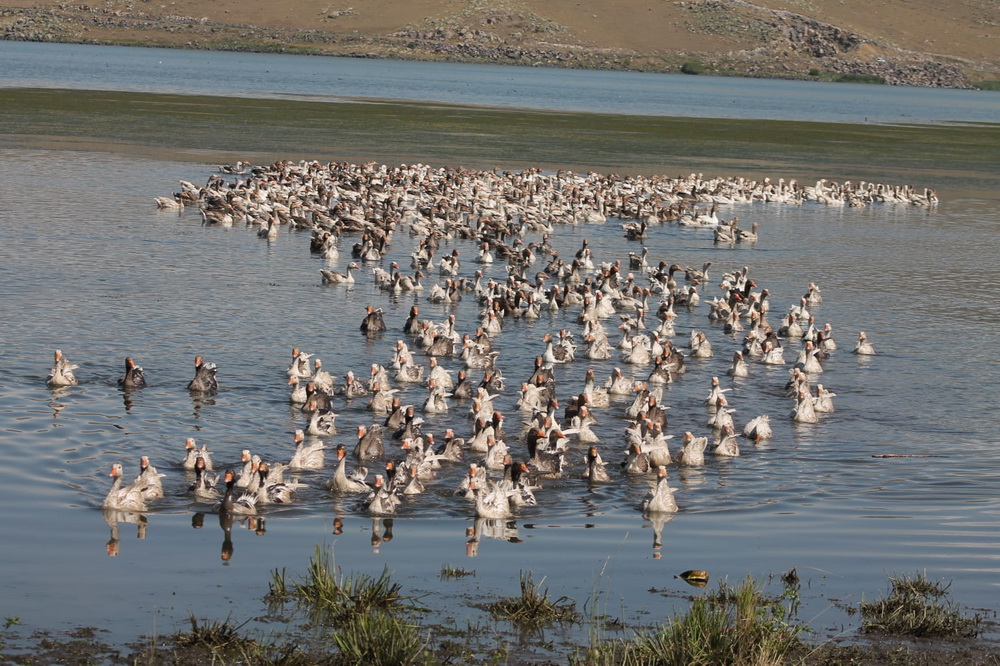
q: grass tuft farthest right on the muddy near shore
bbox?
[860,573,983,638]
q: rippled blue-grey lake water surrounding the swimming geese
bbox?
[0,43,1000,652]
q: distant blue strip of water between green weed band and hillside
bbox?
[0,42,1000,124]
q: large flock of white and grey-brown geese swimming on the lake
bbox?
[88,162,900,518]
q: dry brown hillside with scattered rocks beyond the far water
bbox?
[0,0,1000,87]
